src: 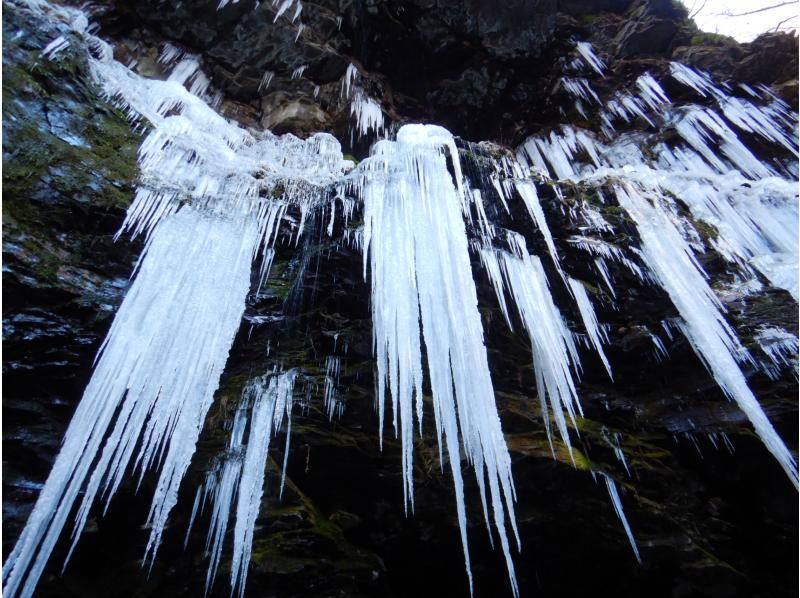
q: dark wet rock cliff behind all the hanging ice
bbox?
[3,0,798,598]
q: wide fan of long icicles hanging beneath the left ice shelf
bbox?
[3,208,258,596]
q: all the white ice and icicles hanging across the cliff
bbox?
[3,0,798,596]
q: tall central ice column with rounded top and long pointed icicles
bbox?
[354,125,519,596]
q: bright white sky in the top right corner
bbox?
[681,0,800,42]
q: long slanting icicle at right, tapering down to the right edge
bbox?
[615,184,798,486]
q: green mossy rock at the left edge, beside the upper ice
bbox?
[3,21,139,220]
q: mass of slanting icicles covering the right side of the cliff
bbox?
[516,52,798,485]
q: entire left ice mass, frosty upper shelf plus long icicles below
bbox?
[3,1,352,596]
